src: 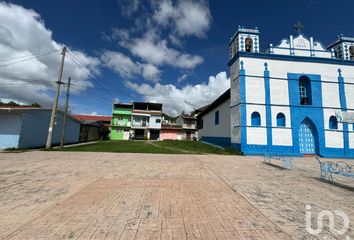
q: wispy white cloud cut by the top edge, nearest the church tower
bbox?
[153,0,212,38]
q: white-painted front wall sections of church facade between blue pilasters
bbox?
[231,57,354,148]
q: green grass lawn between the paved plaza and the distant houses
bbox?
[52,140,239,155]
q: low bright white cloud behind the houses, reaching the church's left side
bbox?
[126,72,230,116]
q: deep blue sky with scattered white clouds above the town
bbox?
[0,0,354,116]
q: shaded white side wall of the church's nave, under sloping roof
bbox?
[198,99,231,138]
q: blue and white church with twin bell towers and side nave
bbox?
[199,23,354,158]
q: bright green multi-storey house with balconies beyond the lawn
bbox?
[111,103,133,140]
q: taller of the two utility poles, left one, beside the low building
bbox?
[46,47,66,148]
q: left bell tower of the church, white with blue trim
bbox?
[229,26,259,58]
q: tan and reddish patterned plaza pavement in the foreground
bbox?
[0,151,354,240]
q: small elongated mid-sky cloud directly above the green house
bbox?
[101,50,161,82]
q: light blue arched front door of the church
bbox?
[299,119,316,154]
